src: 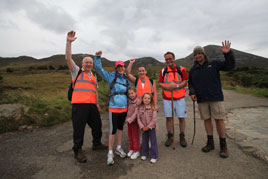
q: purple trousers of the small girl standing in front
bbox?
[141,129,158,159]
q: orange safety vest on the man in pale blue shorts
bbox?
[163,67,186,99]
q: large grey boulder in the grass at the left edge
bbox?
[0,104,29,123]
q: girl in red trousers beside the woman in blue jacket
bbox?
[126,86,140,159]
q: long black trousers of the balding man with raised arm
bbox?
[72,104,102,152]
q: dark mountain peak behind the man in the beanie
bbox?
[175,45,268,68]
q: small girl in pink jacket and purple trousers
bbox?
[137,93,158,163]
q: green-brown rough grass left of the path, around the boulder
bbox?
[0,71,108,133]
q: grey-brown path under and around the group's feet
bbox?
[0,91,268,179]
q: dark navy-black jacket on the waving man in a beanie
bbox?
[188,51,235,103]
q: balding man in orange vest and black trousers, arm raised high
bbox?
[65,31,107,163]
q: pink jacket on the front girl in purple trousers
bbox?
[137,105,157,129]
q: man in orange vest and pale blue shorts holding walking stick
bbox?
[158,52,188,147]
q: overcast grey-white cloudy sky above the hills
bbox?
[0,0,268,61]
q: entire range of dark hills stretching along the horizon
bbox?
[0,45,268,69]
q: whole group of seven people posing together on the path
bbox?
[65,31,235,165]
